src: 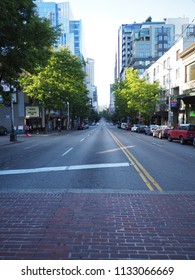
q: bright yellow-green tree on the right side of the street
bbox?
[113,68,161,122]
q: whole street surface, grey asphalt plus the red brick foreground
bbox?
[0,122,195,260]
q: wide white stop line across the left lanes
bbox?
[0,162,131,176]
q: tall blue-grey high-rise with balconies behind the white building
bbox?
[115,18,193,80]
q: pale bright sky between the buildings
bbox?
[44,0,195,106]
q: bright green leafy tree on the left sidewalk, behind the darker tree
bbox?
[19,48,88,127]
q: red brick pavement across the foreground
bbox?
[0,191,195,260]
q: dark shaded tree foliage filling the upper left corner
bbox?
[0,0,59,82]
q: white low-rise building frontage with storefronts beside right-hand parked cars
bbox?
[143,36,195,126]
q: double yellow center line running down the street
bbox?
[108,130,163,192]
